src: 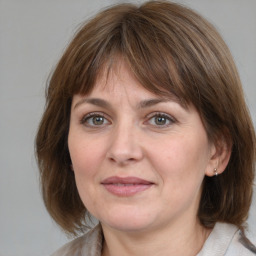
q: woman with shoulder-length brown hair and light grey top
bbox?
[36,1,256,256]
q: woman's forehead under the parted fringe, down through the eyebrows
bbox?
[73,62,187,113]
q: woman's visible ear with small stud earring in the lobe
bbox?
[205,135,232,177]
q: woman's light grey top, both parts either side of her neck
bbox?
[52,222,256,256]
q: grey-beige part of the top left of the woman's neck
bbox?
[51,225,102,256]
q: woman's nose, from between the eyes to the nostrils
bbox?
[107,124,143,165]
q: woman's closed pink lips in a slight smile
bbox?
[101,176,154,197]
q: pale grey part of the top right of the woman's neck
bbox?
[198,223,256,256]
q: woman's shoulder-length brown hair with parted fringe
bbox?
[36,1,255,234]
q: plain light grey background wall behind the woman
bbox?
[0,0,256,256]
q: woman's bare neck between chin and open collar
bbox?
[102,220,211,256]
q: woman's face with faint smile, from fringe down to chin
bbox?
[68,63,216,231]
